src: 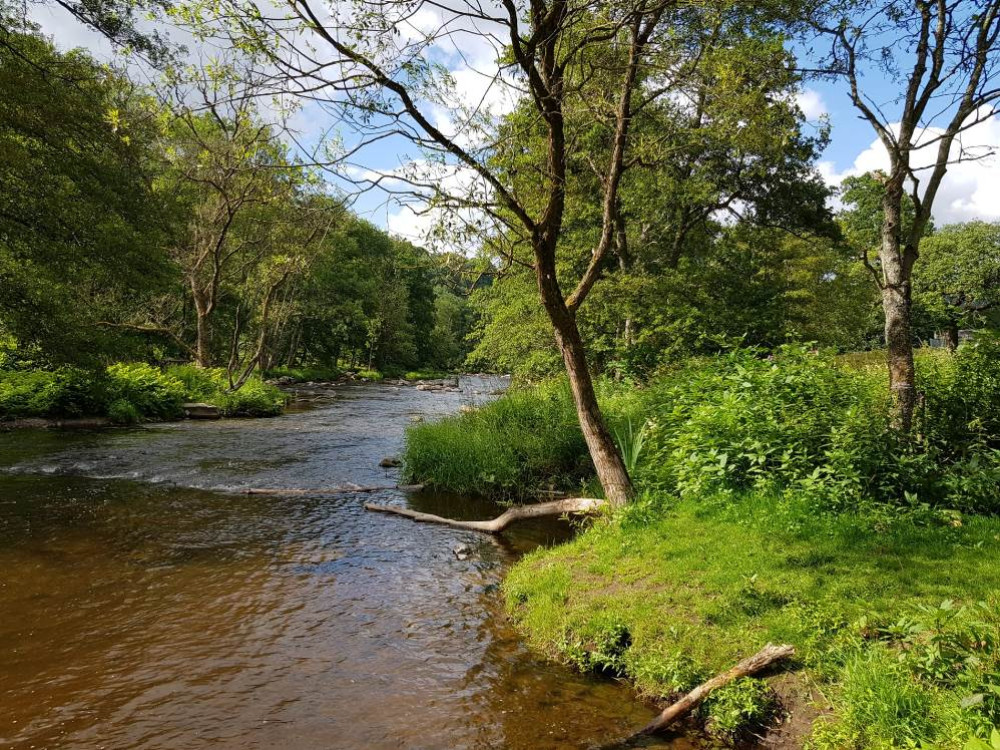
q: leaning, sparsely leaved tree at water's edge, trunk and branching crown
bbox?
[201,0,728,505]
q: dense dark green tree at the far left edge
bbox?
[0,21,173,362]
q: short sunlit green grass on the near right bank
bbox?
[504,493,1000,750]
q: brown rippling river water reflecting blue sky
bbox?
[0,379,691,750]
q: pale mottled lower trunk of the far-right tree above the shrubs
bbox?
[879,183,917,433]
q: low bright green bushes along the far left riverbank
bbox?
[0,363,285,424]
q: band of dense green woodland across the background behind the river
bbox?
[0,0,1000,420]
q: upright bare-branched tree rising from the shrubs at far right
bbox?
[811,0,1000,433]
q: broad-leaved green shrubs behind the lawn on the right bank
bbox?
[638,342,1000,512]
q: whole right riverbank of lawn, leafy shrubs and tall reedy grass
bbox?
[405,341,1000,750]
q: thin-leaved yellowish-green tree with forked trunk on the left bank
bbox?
[151,68,304,367]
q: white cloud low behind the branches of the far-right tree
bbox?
[817,115,1000,224]
